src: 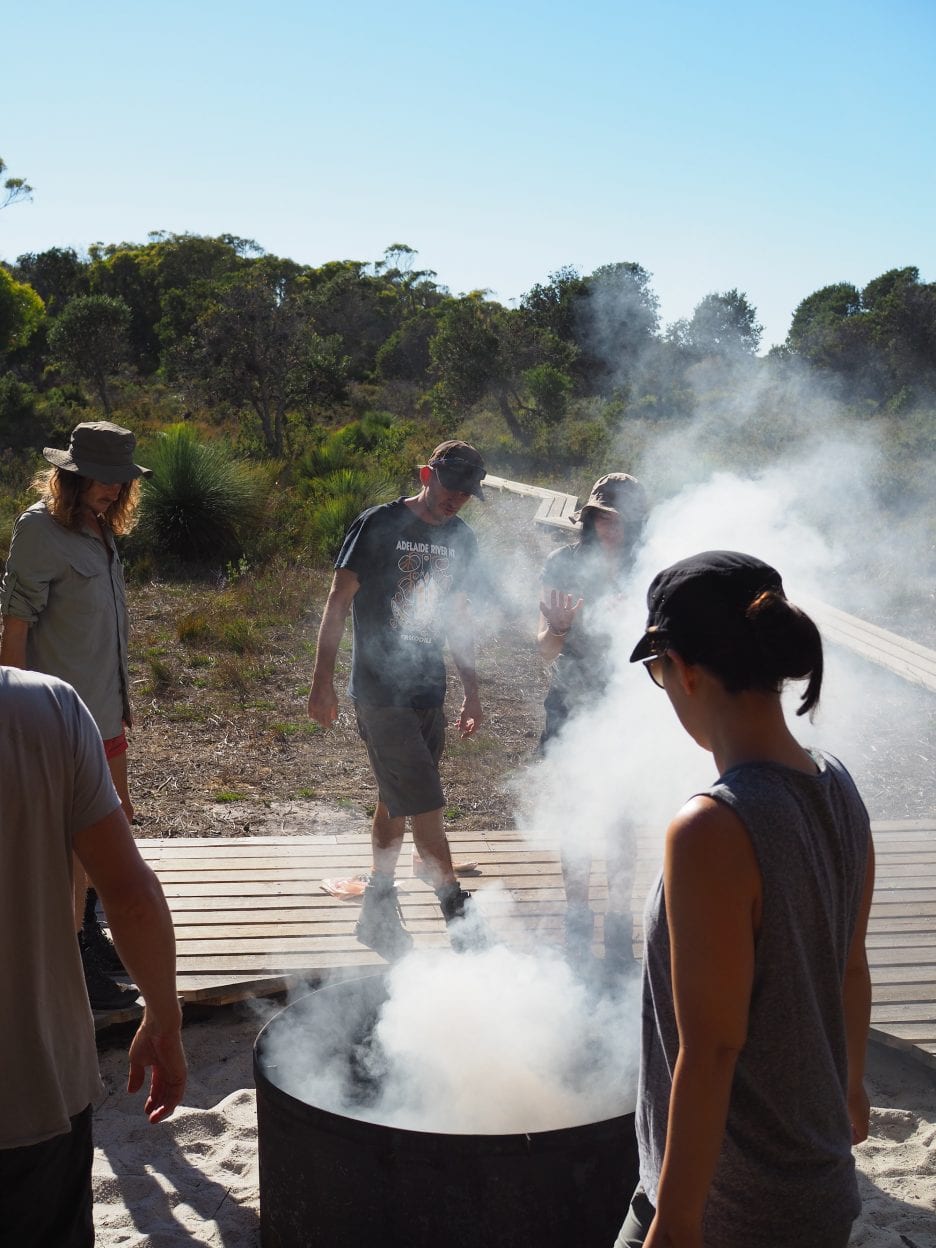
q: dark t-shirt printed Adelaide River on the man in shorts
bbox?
[334,498,478,708]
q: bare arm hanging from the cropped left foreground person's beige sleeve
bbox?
[74,806,186,1122]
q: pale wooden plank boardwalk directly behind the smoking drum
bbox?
[97,817,936,1067]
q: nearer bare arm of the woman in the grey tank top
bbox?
[646,797,761,1248]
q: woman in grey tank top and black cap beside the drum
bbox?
[617,550,874,1248]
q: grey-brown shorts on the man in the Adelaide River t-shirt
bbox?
[354,703,446,819]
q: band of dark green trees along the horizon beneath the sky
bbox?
[0,223,936,463]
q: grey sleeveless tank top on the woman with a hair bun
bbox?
[636,751,870,1248]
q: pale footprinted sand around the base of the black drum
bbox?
[94,1007,936,1248]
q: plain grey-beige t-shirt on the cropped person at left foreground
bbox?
[0,668,120,1148]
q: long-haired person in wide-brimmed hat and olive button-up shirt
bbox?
[0,421,150,1010]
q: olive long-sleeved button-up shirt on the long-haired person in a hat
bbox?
[0,503,130,741]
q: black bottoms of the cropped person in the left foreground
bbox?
[0,1106,95,1248]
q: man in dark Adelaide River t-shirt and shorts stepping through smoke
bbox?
[308,441,484,960]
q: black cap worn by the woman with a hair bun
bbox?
[630,550,784,663]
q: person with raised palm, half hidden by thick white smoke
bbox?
[537,472,646,973]
